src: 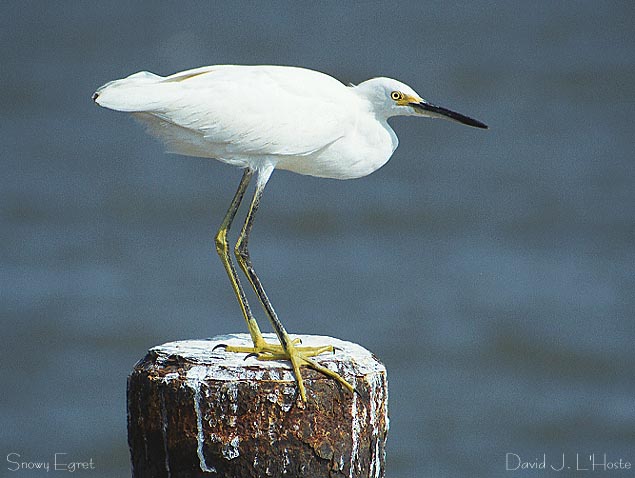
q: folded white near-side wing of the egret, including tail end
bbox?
[96,65,356,159]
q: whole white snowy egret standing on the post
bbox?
[93,65,487,401]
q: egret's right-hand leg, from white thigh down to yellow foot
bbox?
[227,170,353,401]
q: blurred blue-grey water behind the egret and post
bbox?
[0,1,635,478]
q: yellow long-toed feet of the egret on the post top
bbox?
[217,339,355,402]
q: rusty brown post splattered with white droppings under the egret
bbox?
[128,334,388,478]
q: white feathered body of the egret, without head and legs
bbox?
[95,65,396,179]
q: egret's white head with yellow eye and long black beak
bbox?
[355,78,487,129]
